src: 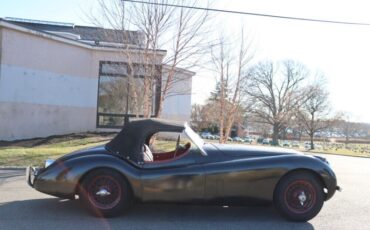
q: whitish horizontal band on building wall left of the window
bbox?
[0,64,98,108]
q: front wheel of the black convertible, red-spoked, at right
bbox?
[274,172,324,222]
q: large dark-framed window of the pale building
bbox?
[97,62,161,128]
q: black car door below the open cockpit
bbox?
[141,150,205,202]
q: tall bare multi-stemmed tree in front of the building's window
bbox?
[88,0,210,117]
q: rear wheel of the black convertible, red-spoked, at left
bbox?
[79,169,132,217]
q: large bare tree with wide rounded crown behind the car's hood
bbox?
[245,60,308,144]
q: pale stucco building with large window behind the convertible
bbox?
[0,19,194,140]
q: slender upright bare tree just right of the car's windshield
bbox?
[211,28,253,143]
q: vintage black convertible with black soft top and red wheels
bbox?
[27,119,340,221]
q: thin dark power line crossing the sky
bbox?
[121,0,370,26]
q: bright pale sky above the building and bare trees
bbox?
[0,0,370,123]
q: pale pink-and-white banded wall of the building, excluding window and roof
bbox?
[0,24,191,140]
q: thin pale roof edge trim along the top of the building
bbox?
[0,18,167,56]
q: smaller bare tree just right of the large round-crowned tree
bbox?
[298,78,331,149]
